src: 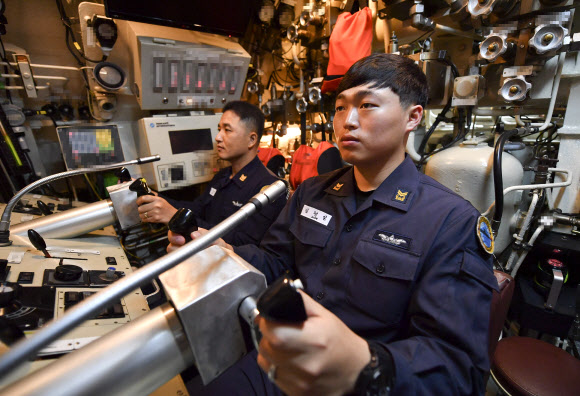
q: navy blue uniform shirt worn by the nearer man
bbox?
[235,157,497,395]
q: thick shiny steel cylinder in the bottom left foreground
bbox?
[0,304,194,396]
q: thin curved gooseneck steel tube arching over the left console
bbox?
[0,155,161,235]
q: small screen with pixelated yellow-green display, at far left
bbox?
[58,125,125,169]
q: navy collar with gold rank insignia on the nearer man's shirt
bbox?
[324,155,419,212]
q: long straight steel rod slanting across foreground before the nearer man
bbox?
[0,180,287,377]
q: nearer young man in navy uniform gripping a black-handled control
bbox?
[168,54,497,395]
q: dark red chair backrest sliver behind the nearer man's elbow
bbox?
[489,270,515,362]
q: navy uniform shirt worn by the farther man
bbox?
[166,156,286,245]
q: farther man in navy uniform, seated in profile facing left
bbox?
[137,101,286,245]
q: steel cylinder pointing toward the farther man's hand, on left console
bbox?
[10,199,117,239]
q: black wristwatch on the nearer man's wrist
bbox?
[354,341,395,396]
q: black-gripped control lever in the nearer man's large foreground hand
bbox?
[238,274,307,350]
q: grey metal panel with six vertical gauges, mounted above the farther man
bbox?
[111,20,251,110]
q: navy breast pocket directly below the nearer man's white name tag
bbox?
[290,217,333,280]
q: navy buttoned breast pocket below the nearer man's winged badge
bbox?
[348,240,420,325]
